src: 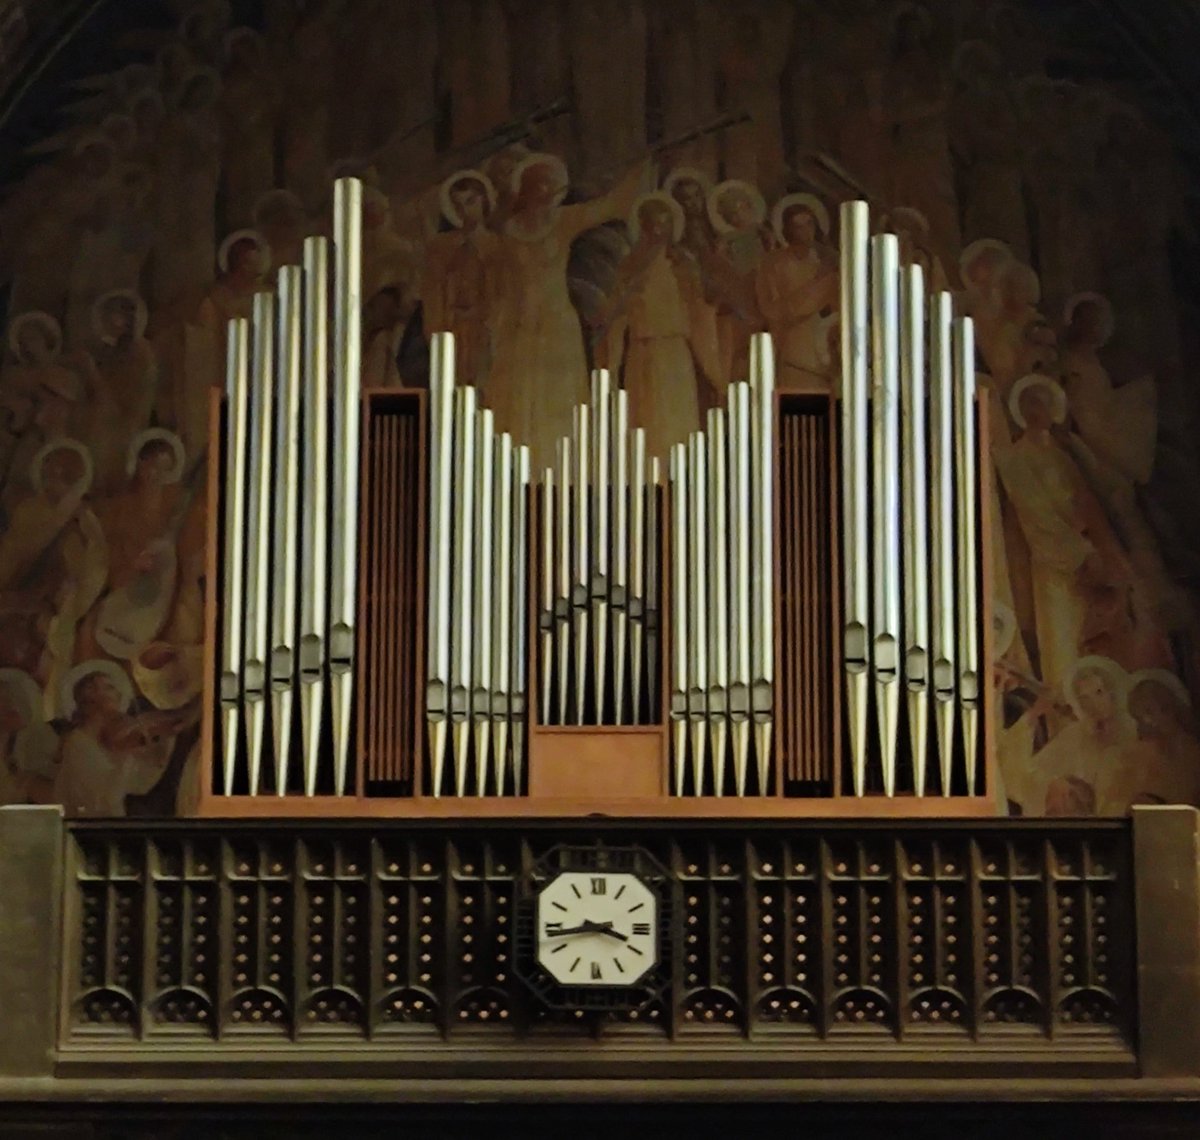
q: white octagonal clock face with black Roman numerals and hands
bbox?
[538,871,659,985]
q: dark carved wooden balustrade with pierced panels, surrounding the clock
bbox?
[59,822,1136,1074]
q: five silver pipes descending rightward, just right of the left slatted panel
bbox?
[425,332,529,796]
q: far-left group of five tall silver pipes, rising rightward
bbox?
[217,179,362,796]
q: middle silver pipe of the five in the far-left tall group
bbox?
[270,265,304,796]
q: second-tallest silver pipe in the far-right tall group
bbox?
[871,234,900,796]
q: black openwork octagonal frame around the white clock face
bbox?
[514,844,672,1013]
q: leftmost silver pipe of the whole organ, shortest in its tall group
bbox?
[218,317,250,796]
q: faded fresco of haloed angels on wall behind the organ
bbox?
[0,0,1200,815]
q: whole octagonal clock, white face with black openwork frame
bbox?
[517,846,670,1009]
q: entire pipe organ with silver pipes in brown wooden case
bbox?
[200,179,995,816]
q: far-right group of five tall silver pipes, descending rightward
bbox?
[841,202,982,796]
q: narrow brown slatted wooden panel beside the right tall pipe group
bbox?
[775,395,835,796]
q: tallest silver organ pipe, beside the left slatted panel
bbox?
[329,178,362,796]
